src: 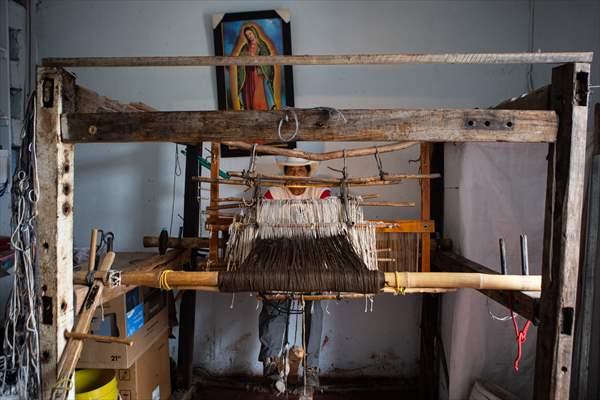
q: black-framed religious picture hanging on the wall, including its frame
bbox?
[213,10,295,157]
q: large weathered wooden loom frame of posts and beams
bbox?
[36,53,592,399]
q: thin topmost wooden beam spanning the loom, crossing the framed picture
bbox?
[42,52,593,67]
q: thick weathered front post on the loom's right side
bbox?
[534,64,590,400]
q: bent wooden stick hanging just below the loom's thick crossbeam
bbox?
[222,141,418,161]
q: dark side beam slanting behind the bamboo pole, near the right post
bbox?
[431,251,540,324]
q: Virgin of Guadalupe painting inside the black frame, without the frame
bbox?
[229,23,281,110]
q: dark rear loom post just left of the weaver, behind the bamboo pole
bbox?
[177,143,202,390]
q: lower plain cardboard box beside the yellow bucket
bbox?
[117,330,171,400]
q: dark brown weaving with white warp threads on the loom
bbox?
[219,198,384,293]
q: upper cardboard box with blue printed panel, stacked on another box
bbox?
[77,287,168,369]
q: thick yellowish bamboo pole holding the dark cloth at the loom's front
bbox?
[121,271,542,292]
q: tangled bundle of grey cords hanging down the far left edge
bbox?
[0,93,41,399]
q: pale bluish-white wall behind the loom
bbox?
[39,0,599,399]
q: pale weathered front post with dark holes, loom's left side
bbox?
[36,68,75,399]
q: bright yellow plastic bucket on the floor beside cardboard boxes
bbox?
[75,369,119,400]
